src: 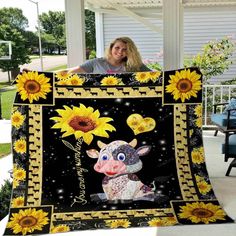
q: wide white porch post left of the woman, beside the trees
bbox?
[65,0,86,67]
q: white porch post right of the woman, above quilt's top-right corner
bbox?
[163,0,183,70]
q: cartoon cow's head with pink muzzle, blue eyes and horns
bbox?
[87,140,150,177]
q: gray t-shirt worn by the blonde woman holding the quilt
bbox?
[80,58,151,74]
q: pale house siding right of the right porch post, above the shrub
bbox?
[184,6,236,83]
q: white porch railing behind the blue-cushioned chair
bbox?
[203,84,236,127]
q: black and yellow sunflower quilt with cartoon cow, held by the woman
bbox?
[5,68,233,235]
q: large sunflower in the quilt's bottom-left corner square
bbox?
[7,208,49,235]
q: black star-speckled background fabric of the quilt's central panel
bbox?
[42,98,181,212]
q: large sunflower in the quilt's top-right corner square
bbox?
[166,69,202,102]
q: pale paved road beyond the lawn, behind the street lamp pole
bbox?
[0,56,67,82]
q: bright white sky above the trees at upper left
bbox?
[0,0,65,32]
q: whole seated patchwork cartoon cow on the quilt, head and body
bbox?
[87,139,154,201]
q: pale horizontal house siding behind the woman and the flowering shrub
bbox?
[103,6,236,83]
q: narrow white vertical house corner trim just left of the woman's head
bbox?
[95,12,105,57]
